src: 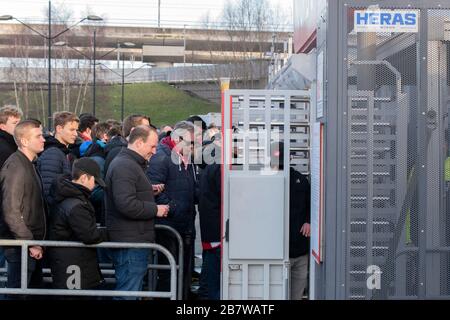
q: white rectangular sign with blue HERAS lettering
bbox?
[355,9,419,33]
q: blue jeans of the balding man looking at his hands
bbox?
[111,249,150,300]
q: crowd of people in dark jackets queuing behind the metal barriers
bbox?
[0,106,309,299]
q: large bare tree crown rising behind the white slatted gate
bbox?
[196,0,291,88]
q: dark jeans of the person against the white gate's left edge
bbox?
[202,247,220,300]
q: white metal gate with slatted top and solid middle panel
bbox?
[221,90,310,300]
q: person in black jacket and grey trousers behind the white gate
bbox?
[271,142,311,300]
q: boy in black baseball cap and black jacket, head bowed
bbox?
[48,158,107,289]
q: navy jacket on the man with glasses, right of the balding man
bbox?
[147,137,196,234]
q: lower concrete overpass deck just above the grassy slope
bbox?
[0,61,269,104]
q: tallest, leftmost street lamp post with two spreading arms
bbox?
[0,1,103,129]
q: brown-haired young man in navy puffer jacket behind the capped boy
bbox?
[37,111,80,206]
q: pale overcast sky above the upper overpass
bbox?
[0,0,292,27]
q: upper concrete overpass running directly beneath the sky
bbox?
[0,23,291,66]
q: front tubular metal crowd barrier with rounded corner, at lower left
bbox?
[0,240,178,300]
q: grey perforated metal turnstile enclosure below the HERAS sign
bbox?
[344,5,450,299]
